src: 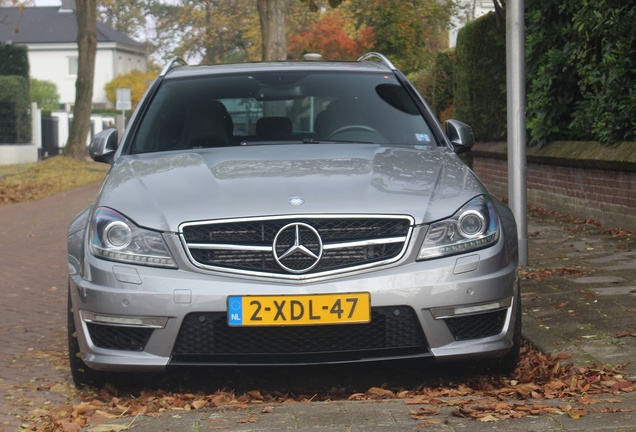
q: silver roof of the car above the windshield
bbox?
[162,61,392,79]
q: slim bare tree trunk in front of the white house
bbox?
[63,0,97,159]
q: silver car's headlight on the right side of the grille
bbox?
[417,195,499,260]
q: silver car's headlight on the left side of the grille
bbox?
[90,207,177,268]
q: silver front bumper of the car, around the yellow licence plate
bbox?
[70,230,518,371]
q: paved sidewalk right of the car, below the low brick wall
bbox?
[522,218,636,377]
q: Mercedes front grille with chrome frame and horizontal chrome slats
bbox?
[180,215,413,279]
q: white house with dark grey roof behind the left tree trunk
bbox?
[0,0,147,110]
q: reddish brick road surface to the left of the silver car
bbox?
[0,184,99,431]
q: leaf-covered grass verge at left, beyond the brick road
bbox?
[0,156,108,205]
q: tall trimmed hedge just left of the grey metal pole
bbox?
[454,13,506,141]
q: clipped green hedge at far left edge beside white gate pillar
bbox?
[0,75,31,143]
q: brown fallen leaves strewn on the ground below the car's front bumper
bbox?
[23,346,636,432]
